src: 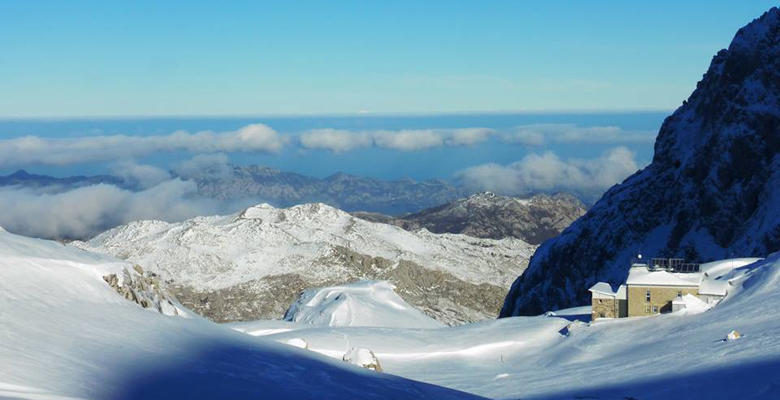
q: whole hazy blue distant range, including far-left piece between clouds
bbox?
[0,165,471,215]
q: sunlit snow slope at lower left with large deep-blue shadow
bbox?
[0,231,488,400]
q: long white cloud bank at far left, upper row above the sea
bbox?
[0,124,286,167]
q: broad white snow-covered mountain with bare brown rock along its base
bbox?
[73,203,535,324]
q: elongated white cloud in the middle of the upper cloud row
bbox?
[300,128,494,153]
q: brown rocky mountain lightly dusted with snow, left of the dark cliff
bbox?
[353,192,587,244]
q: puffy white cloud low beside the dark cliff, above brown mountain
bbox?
[457,147,639,201]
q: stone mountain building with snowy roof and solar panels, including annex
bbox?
[589,256,761,321]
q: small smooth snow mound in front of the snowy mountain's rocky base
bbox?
[284,281,444,328]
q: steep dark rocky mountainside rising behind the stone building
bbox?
[500,8,780,316]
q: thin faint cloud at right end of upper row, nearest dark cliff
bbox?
[503,124,656,146]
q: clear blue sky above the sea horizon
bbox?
[0,0,774,117]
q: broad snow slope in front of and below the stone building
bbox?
[236,254,780,400]
